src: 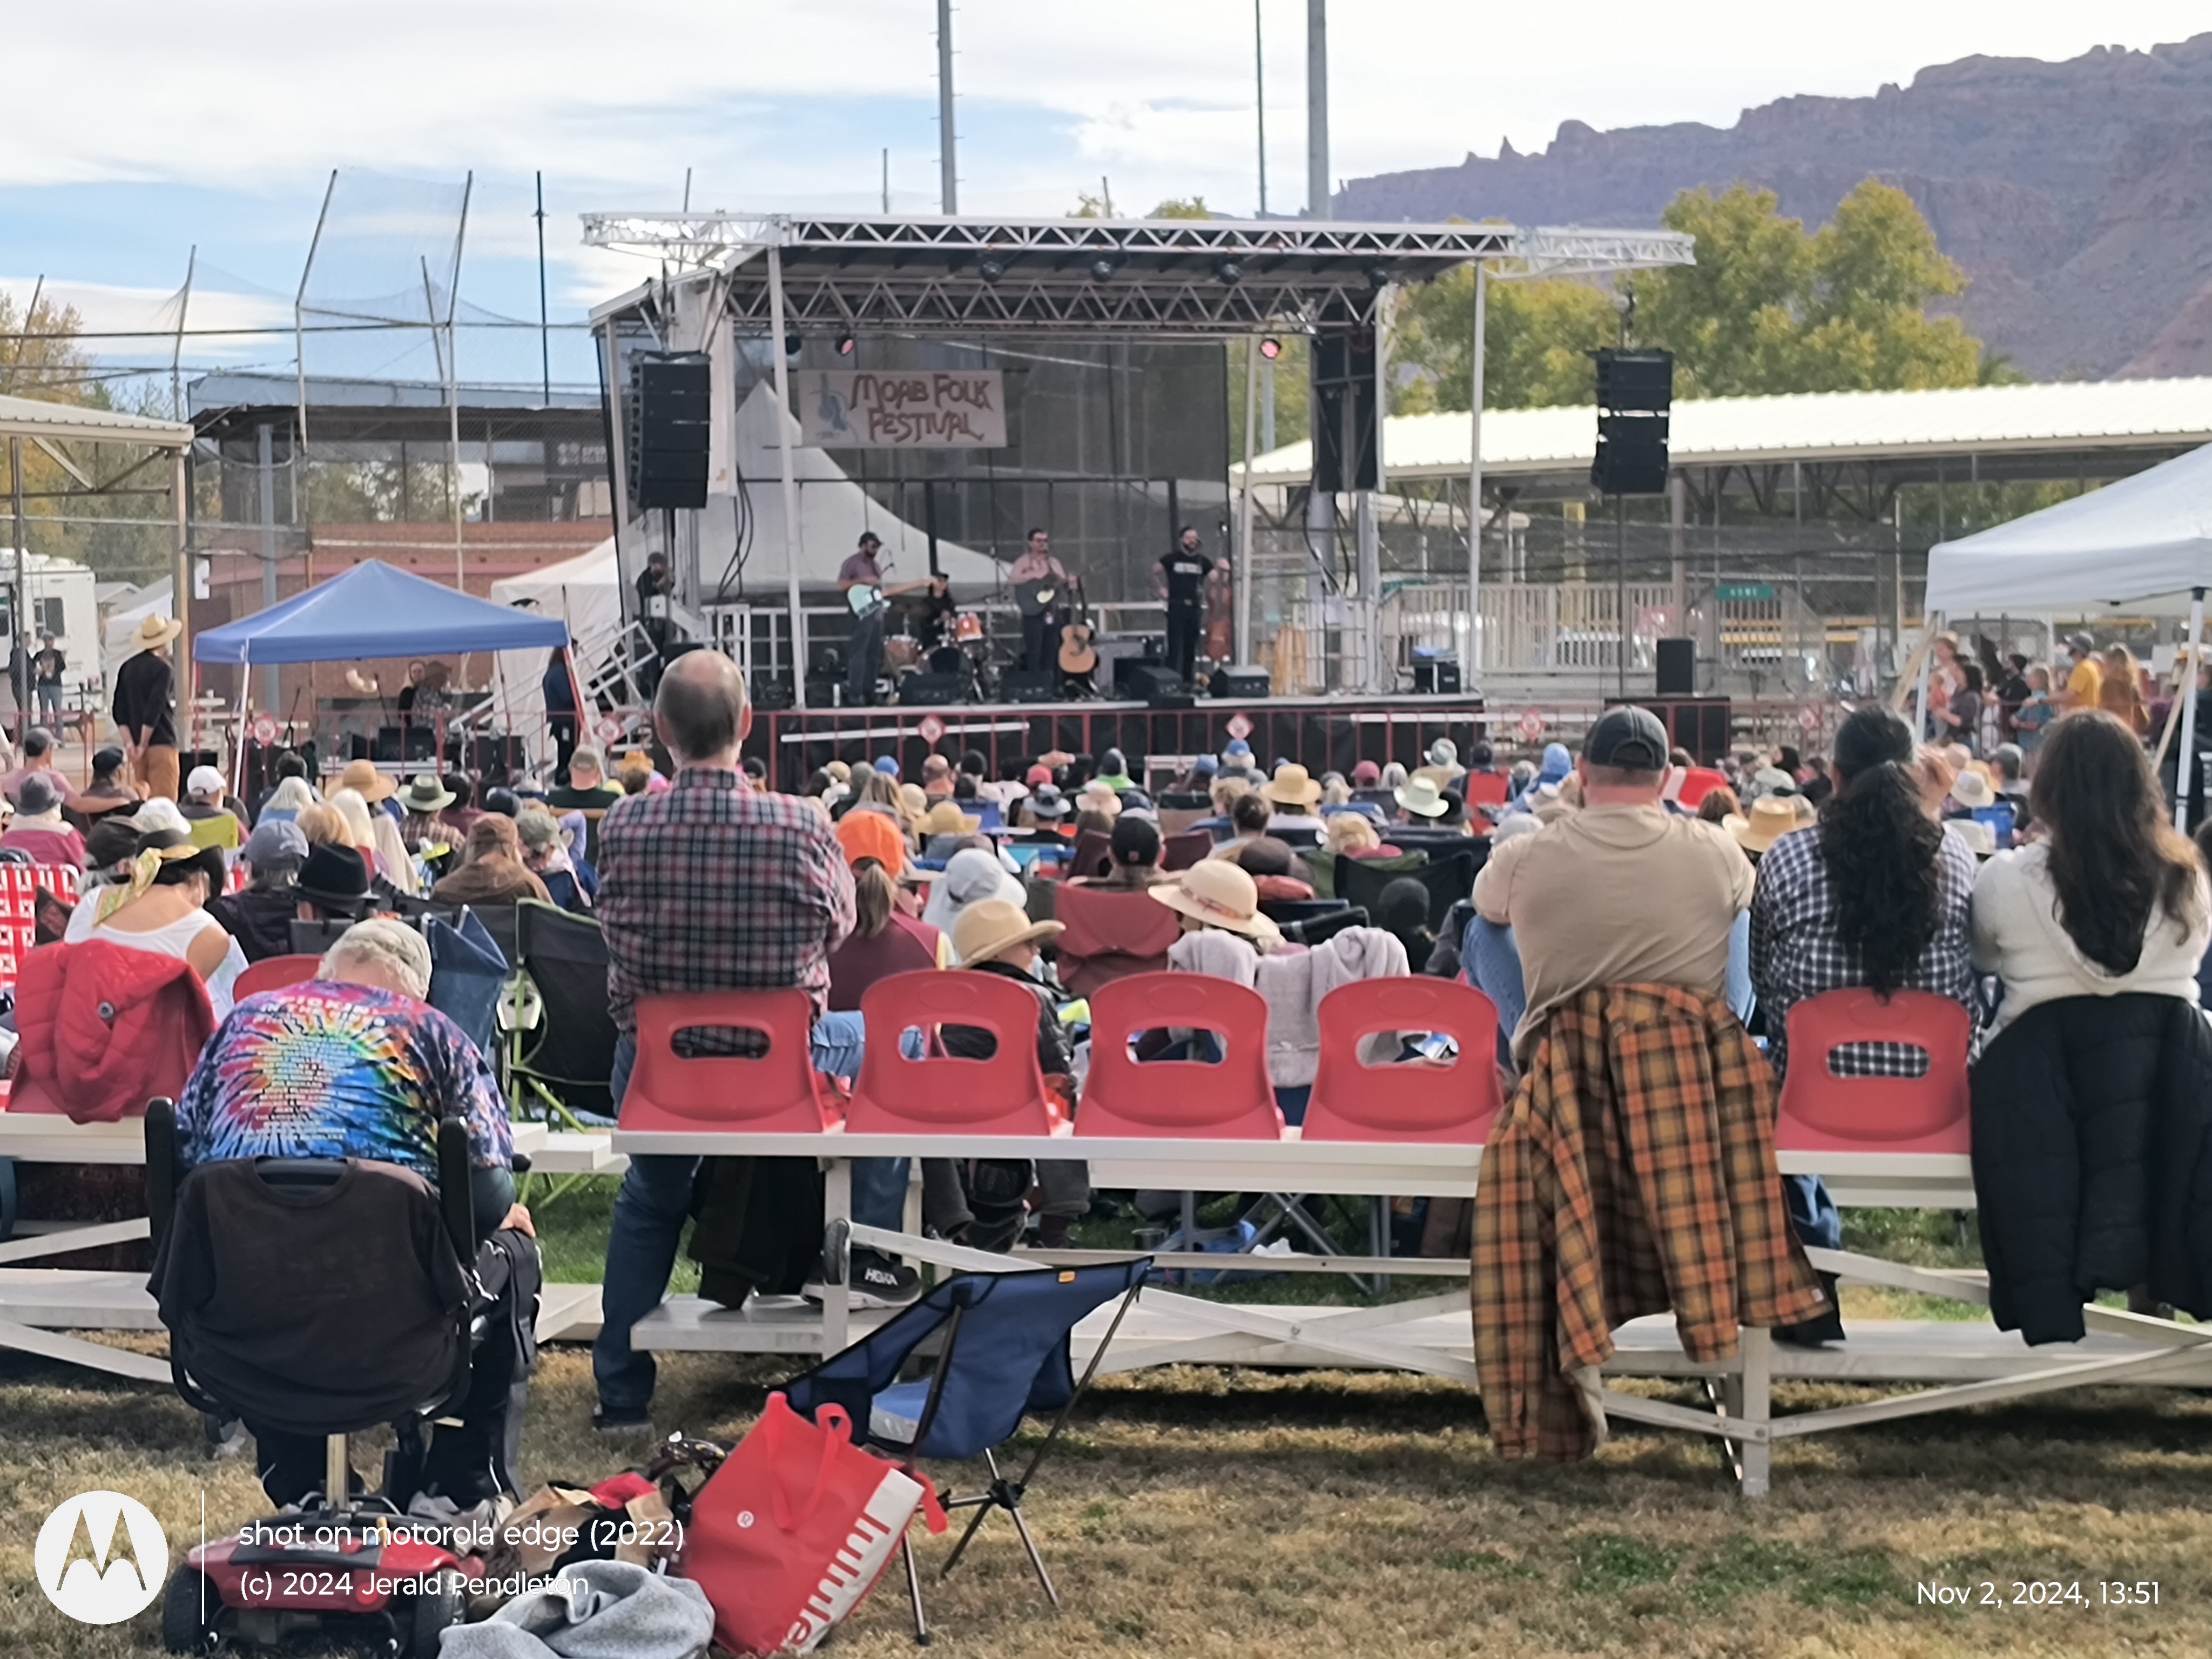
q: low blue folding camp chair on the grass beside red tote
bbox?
[783,1257,1152,1641]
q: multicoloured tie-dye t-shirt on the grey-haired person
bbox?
[177,980,515,1181]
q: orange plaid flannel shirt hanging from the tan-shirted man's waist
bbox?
[1471,984,1827,1458]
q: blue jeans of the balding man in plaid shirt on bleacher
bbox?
[591,1013,907,1411]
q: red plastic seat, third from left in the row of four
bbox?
[1075,973,1283,1142]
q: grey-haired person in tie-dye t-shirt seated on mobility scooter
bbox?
[177,920,537,1508]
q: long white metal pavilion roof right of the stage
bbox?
[1252,378,2212,484]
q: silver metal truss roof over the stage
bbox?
[584,212,1692,339]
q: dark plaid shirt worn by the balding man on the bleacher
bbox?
[597,767,854,1053]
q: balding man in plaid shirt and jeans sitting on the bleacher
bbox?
[593,650,918,1429]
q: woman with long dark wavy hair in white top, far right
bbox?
[1973,710,2212,1035]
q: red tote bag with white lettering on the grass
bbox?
[677,1393,945,1655]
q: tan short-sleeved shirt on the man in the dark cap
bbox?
[1475,805,1752,1053]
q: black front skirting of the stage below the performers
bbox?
[745,697,1484,790]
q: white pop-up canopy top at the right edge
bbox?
[1927,444,2212,617]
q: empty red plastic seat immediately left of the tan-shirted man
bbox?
[1298,977,1506,1146]
